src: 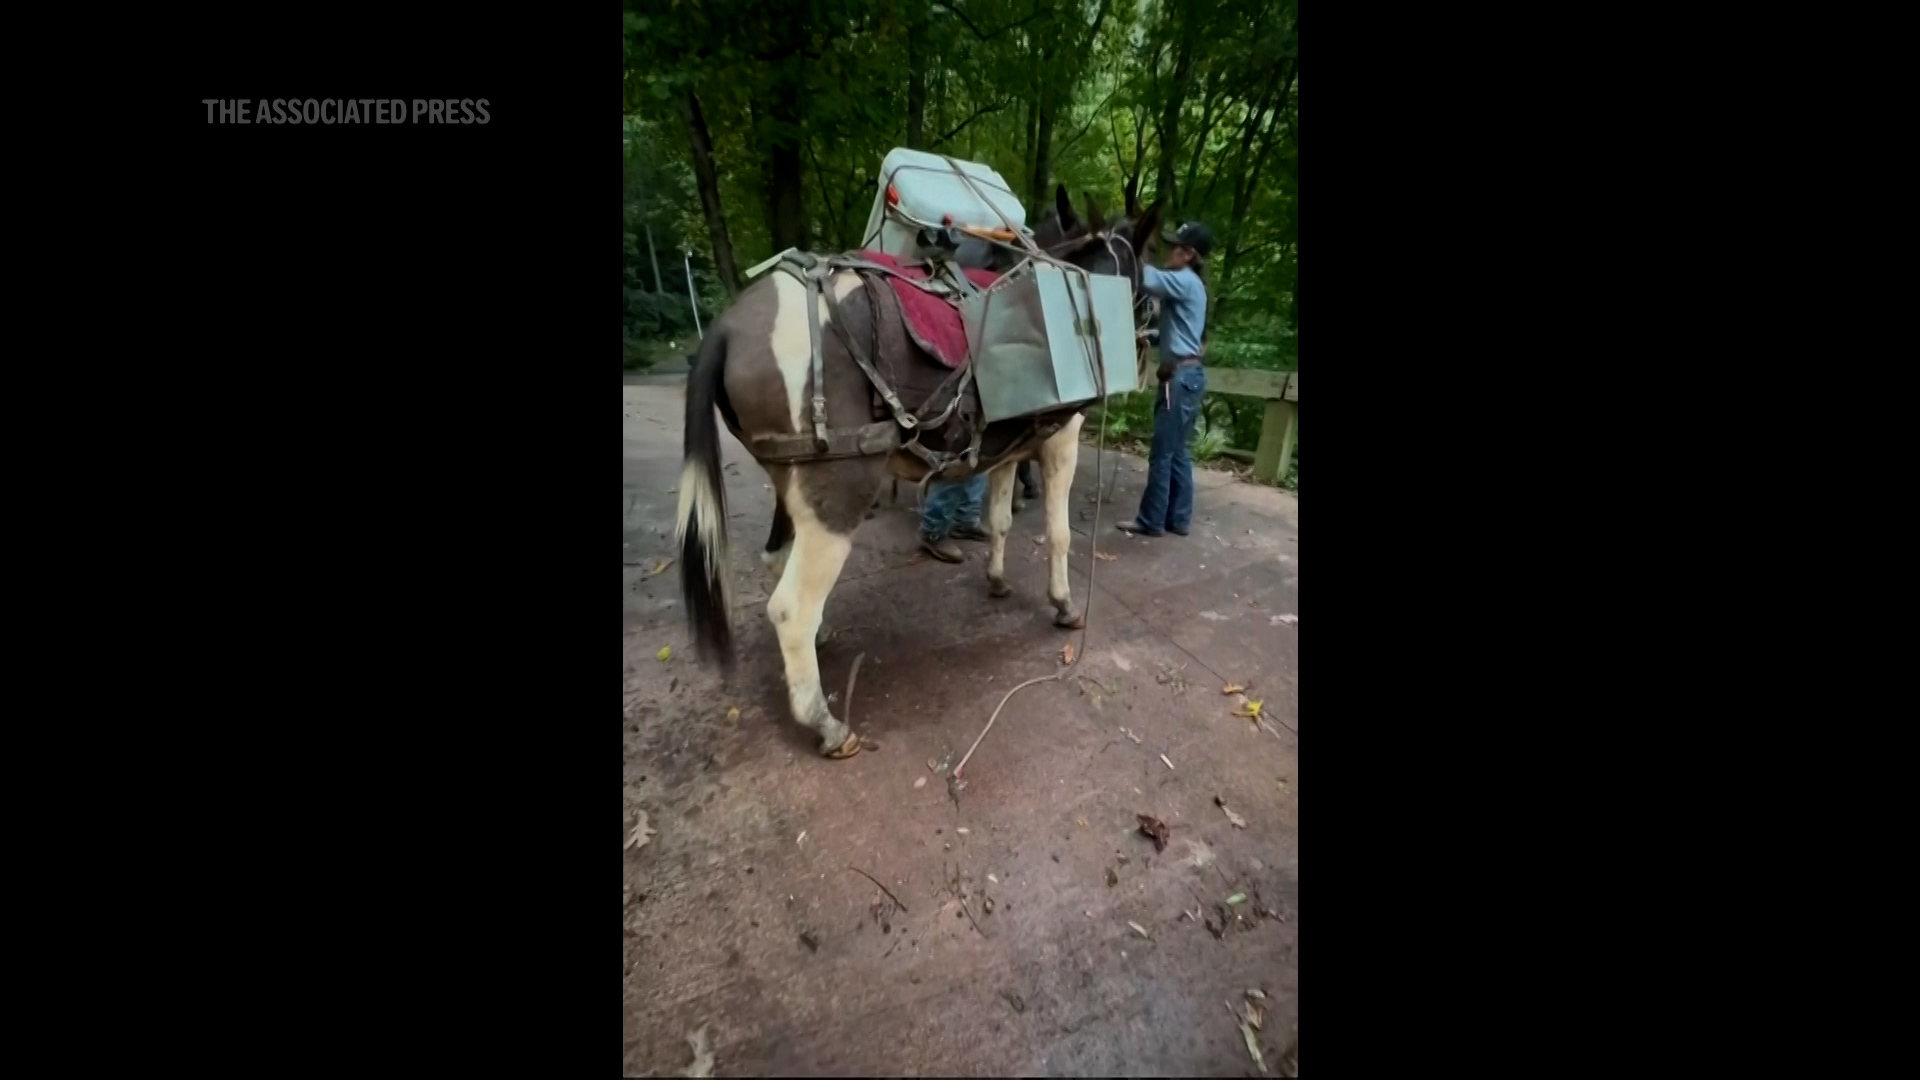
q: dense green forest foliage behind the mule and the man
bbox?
[622,0,1300,470]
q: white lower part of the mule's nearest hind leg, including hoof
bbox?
[766,513,860,757]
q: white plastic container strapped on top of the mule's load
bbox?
[862,146,1027,259]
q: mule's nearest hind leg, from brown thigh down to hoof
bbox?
[766,459,883,757]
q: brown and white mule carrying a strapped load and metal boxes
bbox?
[676,188,1160,757]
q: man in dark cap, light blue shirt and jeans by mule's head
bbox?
[1119,221,1213,536]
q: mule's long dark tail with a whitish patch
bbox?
[674,334,733,667]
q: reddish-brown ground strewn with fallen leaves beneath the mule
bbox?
[622,380,1300,1076]
